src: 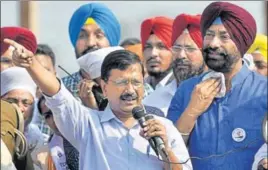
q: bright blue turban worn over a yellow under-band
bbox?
[69,3,121,47]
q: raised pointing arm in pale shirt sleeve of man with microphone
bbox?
[5,39,90,149]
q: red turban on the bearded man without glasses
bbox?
[141,17,173,49]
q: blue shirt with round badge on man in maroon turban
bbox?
[167,65,267,170]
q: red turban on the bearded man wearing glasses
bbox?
[171,14,202,48]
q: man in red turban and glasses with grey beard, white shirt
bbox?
[143,14,207,116]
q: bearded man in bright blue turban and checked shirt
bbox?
[62,3,121,97]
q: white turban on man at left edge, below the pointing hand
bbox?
[1,67,37,98]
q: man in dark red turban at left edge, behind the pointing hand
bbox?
[0,27,37,72]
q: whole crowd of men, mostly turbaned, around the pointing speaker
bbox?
[1,2,268,170]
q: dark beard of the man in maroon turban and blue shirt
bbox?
[203,47,240,73]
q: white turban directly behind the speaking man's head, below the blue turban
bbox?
[77,46,124,79]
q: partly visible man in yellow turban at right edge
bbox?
[247,34,268,77]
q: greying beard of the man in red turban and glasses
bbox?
[173,58,205,85]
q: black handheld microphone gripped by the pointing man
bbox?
[132,106,168,159]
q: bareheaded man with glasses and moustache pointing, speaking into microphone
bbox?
[5,36,191,170]
